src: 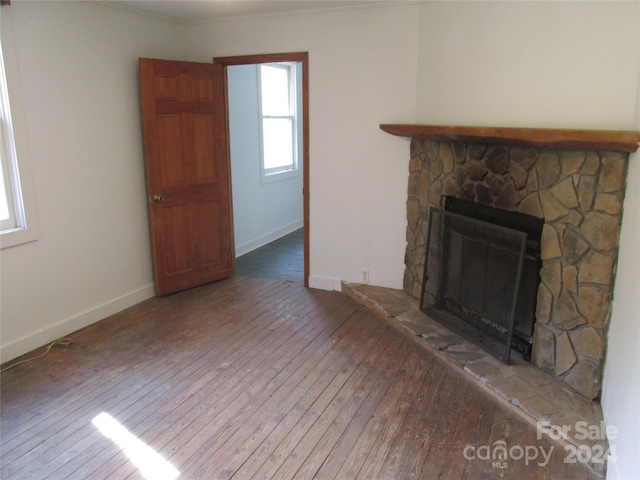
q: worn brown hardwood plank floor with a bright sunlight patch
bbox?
[0,276,591,480]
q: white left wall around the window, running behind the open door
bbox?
[0,1,184,361]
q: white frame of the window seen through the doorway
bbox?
[256,62,300,183]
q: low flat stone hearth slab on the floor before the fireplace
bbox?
[342,282,608,475]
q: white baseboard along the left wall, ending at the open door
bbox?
[0,284,155,363]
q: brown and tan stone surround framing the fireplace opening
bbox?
[404,138,628,399]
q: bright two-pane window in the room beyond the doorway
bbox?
[258,63,298,179]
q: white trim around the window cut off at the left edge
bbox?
[0,28,39,249]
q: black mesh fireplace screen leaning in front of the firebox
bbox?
[420,203,538,363]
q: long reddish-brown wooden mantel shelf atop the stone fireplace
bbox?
[380,124,640,153]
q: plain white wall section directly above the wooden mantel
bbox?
[418,1,640,129]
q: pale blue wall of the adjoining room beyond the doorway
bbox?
[227,65,303,257]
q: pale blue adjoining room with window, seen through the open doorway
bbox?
[227,57,305,283]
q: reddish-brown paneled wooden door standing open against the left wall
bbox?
[139,59,235,295]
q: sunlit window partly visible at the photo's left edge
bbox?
[0,37,37,248]
